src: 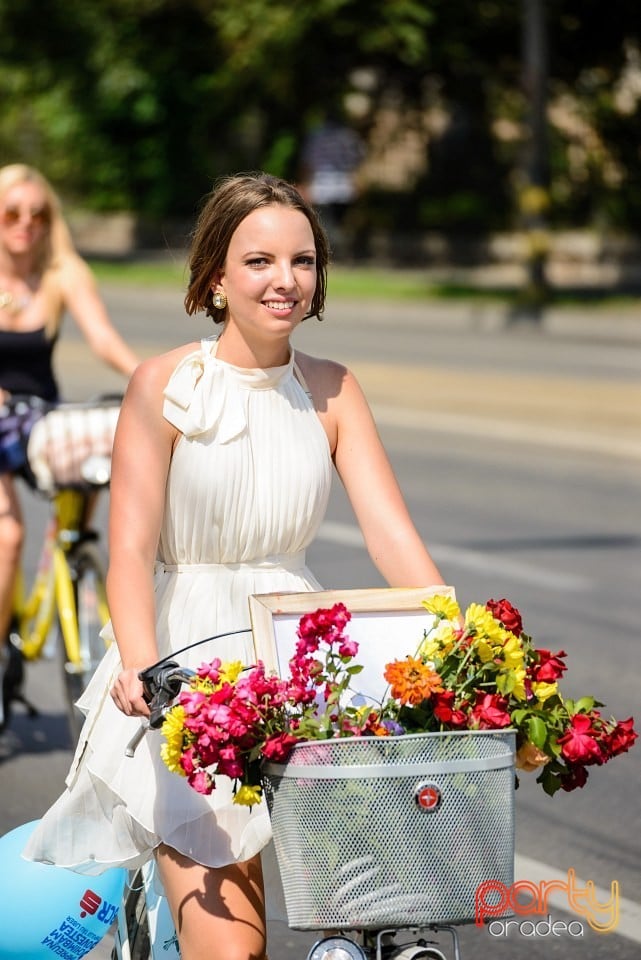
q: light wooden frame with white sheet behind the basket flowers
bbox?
[249,585,455,703]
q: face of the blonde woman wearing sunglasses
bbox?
[0,180,51,256]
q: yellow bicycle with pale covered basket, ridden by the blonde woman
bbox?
[3,395,121,741]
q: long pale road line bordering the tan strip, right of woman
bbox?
[372,403,641,460]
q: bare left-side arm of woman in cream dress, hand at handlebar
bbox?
[107,354,177,715]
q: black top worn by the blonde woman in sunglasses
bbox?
[0,327,58,402]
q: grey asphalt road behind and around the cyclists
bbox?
[0,287,641,960]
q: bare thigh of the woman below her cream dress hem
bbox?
[156,845,266,960]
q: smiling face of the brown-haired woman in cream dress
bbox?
[212,204,317,339]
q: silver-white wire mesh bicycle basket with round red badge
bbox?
[263,730,515,930]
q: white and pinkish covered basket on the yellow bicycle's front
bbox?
[27,400,120,492]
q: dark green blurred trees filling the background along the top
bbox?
[0,0,641,231]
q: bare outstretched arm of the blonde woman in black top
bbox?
[60,256,139,377]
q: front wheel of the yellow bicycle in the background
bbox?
[59,541,108,742]
